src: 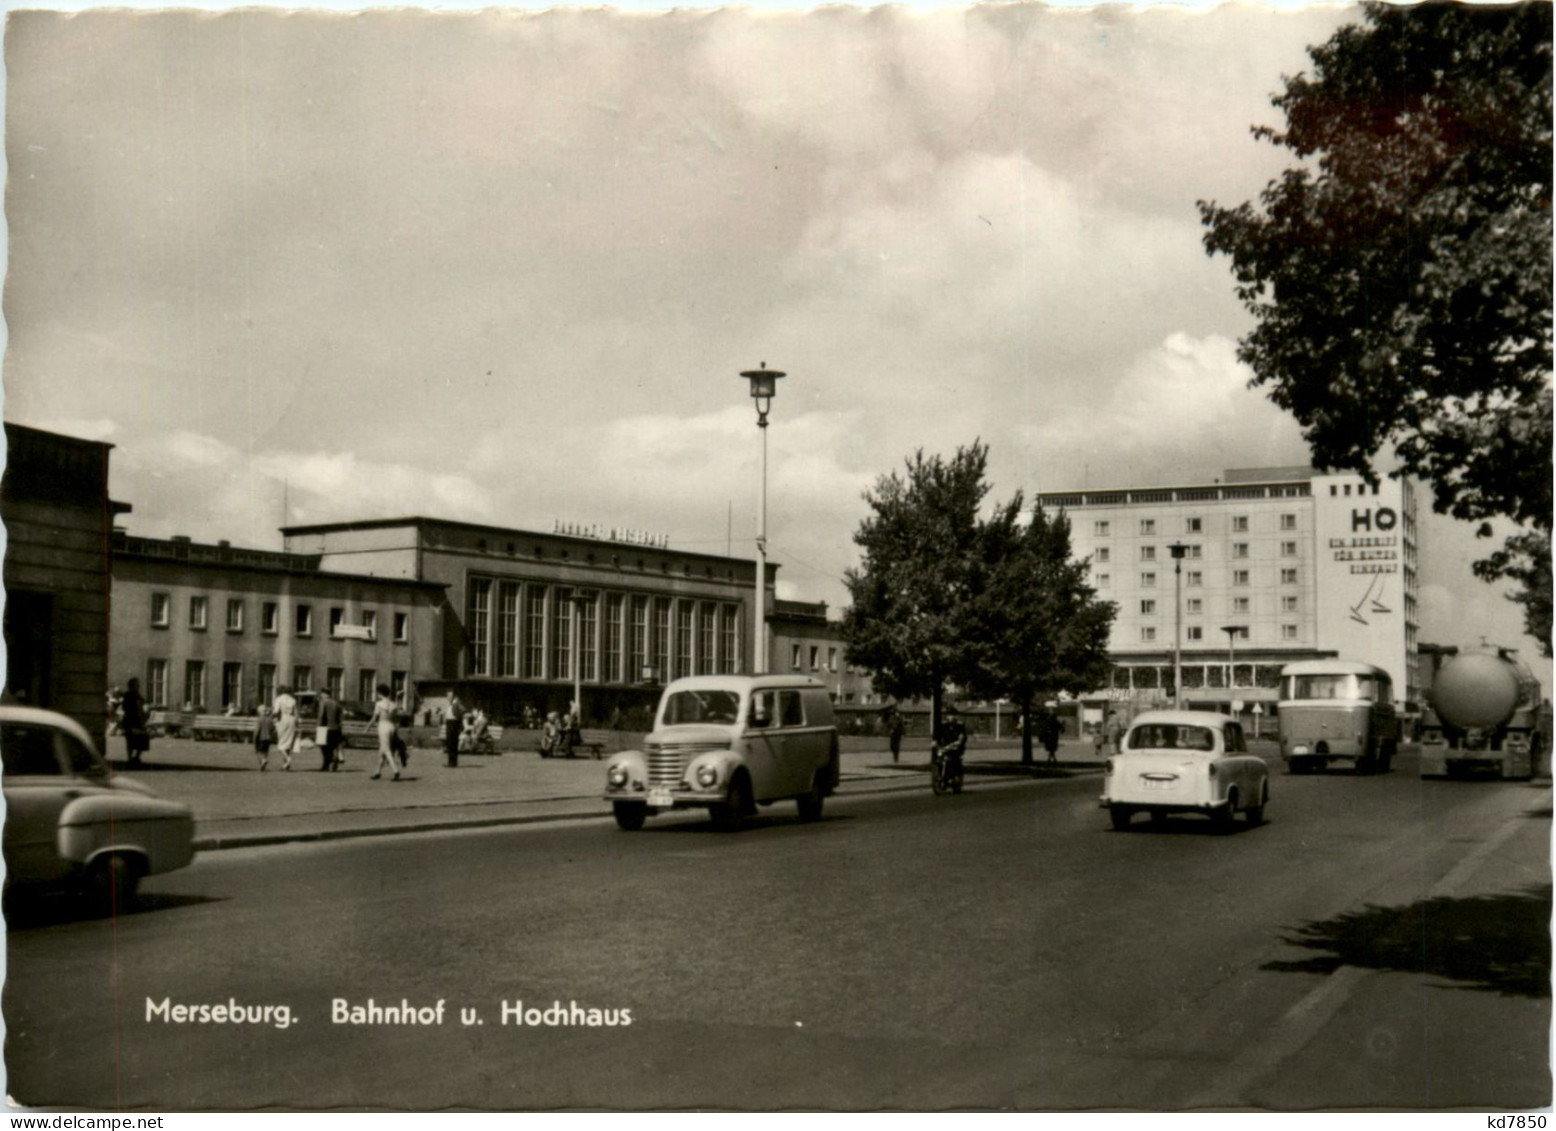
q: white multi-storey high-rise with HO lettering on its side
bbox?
[1036,468,1424,713]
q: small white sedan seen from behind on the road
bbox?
[1100,711,1270,829]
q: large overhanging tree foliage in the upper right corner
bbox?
[1200,3,1551,655]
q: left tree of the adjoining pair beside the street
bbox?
[843,440,991,731]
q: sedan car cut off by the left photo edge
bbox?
[0,706,195,910]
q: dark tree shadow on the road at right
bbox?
[1263,884,1551,997]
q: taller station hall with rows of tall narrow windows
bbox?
[282,516,778,725]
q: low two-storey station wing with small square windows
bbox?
[109,530,443,714]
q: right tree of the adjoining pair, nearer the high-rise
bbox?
[969,510,1117,764]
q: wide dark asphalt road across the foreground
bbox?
[5,756,1551,1111]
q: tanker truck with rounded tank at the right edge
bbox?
[1421,647,1551,778]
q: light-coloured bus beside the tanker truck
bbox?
[1277,660,1400,773]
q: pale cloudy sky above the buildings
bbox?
[5,5,1534,678]
